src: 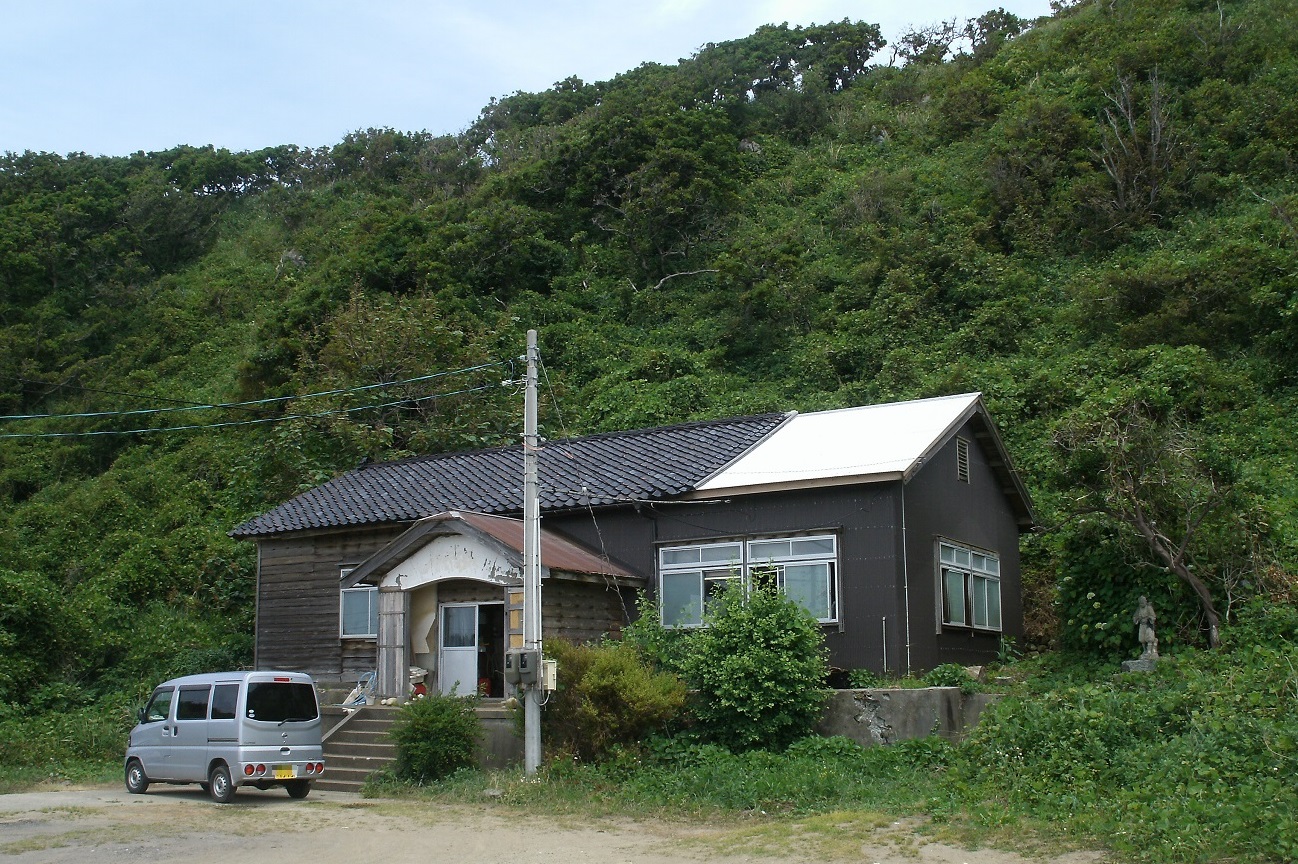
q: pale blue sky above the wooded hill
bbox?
[0,0,1050,156]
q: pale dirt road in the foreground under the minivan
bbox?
[0,786,1102,864]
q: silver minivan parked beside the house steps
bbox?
[126,672,325,804]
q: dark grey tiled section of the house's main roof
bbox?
[230,414,785,537]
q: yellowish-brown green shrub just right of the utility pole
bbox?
[541,640,685,760]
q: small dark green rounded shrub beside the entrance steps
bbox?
[388,695,483,785]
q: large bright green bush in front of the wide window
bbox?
[685,585,828,751]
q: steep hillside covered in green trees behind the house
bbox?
[0,0,1298,762]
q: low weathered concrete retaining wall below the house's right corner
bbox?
[816,688,998,747]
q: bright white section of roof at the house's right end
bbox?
[696,393,981,497]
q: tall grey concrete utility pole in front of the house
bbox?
[523,330,541,776]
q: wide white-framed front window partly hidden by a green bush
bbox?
[658,534,839,627]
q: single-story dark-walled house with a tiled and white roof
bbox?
[231,393,1033,695]
